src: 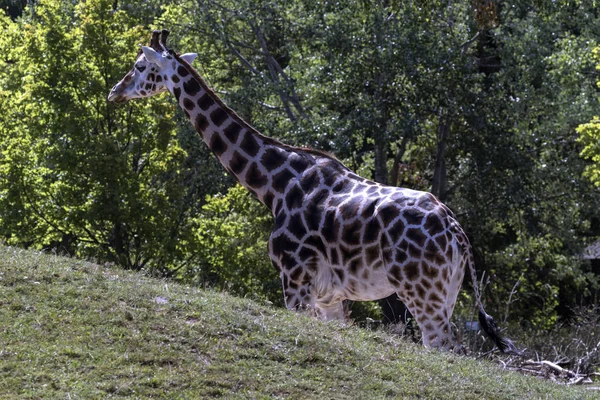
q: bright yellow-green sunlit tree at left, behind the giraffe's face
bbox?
[0,0,209,269]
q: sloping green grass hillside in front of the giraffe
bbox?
[0,246,597,399]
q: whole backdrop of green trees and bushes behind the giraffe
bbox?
[0,0,600,327]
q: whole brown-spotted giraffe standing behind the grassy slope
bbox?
[108,30,517,352]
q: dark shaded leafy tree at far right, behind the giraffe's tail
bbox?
[448,2,599,326]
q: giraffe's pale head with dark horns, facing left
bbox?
[108,30,197,103]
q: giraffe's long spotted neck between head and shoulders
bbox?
[169,57,316,211]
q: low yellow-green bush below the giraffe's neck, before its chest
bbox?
[180,185,283,305]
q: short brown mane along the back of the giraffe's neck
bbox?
[171,51,348,169]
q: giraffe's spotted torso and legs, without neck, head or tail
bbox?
[269,165,469,346]
